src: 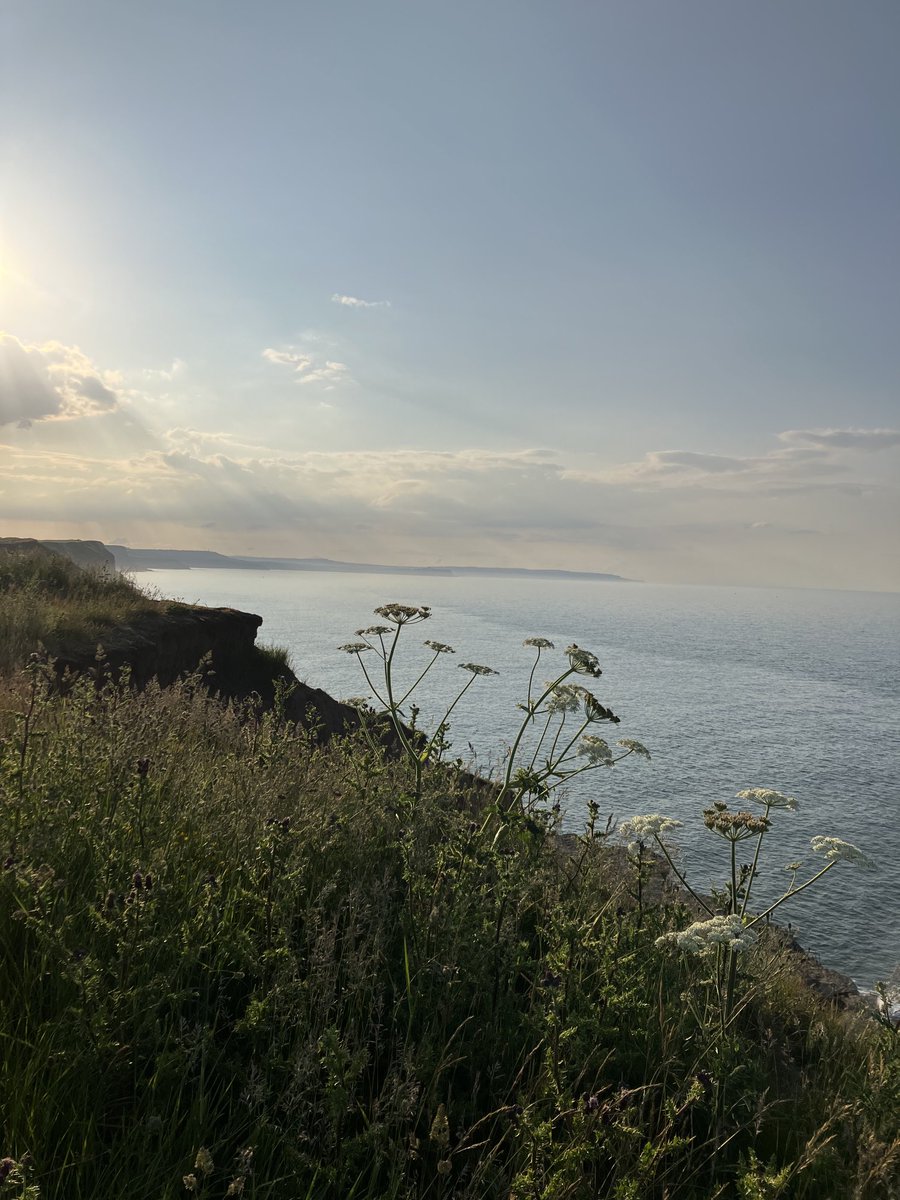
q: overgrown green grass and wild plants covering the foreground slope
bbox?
[0,566,900,1200]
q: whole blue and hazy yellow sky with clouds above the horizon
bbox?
[0,0,900,590]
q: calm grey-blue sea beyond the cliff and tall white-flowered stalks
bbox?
[139,570,900,988]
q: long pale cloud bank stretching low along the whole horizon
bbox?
[0,403,900,589]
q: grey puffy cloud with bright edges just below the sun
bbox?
[0,334,119,427]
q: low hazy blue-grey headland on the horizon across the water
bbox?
[106,546,635,583]
